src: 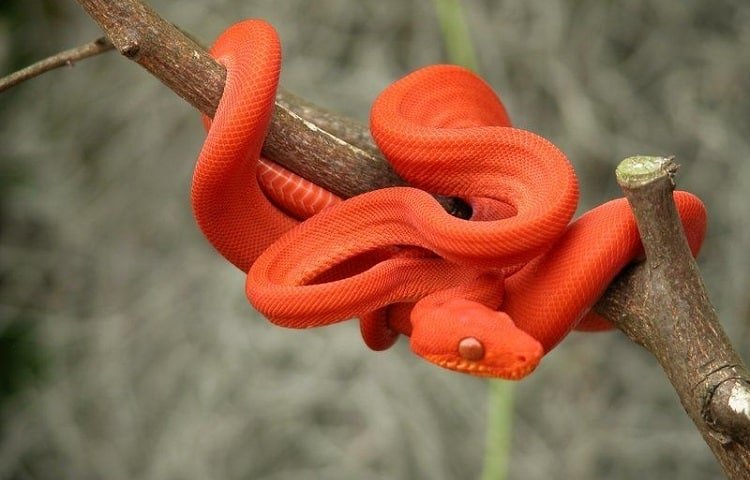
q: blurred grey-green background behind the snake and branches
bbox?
[0,0,750,479]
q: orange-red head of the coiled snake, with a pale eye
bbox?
[410,298,544,380]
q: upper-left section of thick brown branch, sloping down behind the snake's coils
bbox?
[73,0,468,216]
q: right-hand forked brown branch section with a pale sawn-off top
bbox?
[596,157,750,479]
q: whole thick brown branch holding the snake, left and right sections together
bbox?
[67,0,750,472]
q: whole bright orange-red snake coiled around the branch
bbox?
[192,20,706,379]
